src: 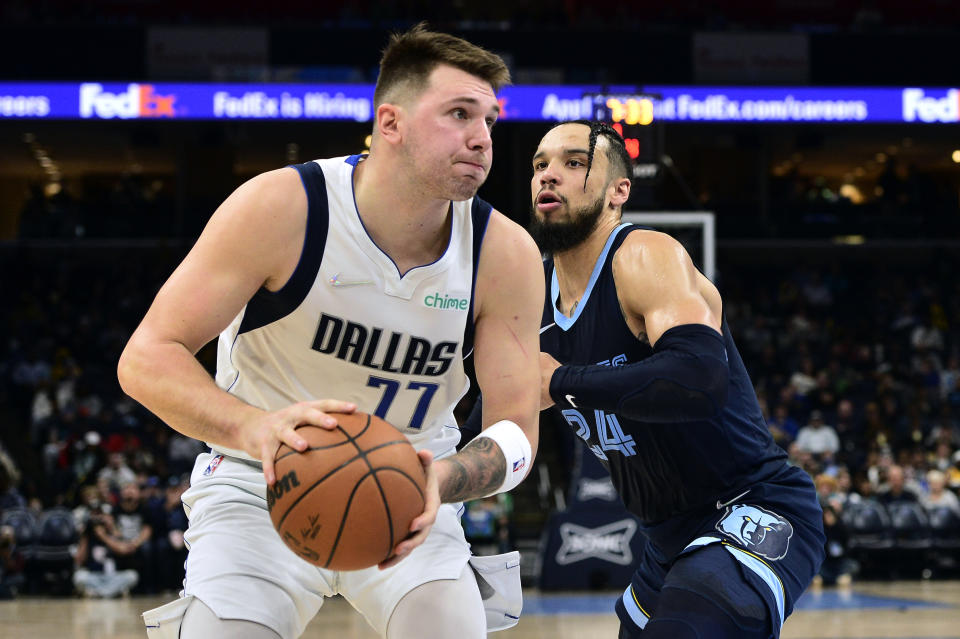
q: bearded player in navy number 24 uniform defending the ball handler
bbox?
[531,121,823,639]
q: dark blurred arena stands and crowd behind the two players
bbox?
[0,0,960,597]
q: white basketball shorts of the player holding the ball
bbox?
[183,453,470,639]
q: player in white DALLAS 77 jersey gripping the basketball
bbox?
[118,26,544,639]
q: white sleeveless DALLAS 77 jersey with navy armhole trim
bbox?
[216,156,491,459]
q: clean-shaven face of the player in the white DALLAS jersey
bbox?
[404,65,500,201]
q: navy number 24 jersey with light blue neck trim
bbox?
[540,224,786,546]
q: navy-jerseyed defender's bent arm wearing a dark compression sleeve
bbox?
[541,231,729,423]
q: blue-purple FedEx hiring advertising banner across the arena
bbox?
[0,82,960,124]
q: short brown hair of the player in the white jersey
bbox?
[373,22,510,108]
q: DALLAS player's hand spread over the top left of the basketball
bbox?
[243,399,357,486]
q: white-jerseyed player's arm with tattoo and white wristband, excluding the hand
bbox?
[437,211,544,502]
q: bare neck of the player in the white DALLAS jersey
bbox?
[353,157,452,274]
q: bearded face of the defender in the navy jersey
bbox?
[530,124,609,253]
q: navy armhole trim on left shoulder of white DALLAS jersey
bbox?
[237,162,330,335]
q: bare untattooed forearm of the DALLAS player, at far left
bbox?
[117,337,261,448]
